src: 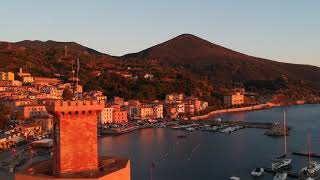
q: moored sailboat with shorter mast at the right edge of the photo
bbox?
[301,135,320,178]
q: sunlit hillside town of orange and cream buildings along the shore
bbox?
[0,68,304,150]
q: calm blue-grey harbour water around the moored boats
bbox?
[99,105,320,180]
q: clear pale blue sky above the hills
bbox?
[0,0,320,66]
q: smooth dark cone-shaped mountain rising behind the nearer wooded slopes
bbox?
[121,34,320,82]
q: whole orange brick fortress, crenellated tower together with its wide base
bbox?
[15,100,130,180]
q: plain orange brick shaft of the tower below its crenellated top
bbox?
[54,112,98,174]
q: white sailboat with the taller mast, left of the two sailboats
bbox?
[271,110,292,171]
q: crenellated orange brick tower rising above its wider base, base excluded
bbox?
[47,100,105,175]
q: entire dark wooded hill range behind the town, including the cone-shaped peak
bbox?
[0,34,320,104]
